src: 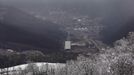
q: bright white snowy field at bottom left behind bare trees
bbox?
[0,62,65,73]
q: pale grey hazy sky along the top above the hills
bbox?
[0,0,134,19]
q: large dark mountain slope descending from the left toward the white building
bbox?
[0,7,64,50]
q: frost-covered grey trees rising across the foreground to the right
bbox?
[3,32,134,75]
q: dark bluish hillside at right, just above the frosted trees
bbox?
[102,17,134,44]
